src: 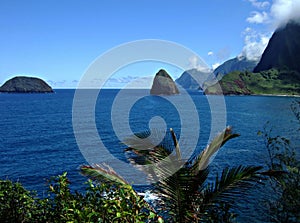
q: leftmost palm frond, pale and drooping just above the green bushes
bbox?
[80,164,129,185]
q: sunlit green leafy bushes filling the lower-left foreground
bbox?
[0,173,157,223]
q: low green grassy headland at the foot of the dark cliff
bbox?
[204,69,300,95]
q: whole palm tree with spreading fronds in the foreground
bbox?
[81,127,262,222]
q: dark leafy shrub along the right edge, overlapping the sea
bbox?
[260,101,300,222]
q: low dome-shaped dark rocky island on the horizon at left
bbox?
[0,76,54,93]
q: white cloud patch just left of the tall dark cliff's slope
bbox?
[240,28,270,61]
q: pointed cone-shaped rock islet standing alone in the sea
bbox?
[150,69,179,95]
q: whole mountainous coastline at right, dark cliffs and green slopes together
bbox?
[176,21,300,95]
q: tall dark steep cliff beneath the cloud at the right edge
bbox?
[254,21,300,72]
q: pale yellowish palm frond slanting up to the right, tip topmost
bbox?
[192,126,239,172]
